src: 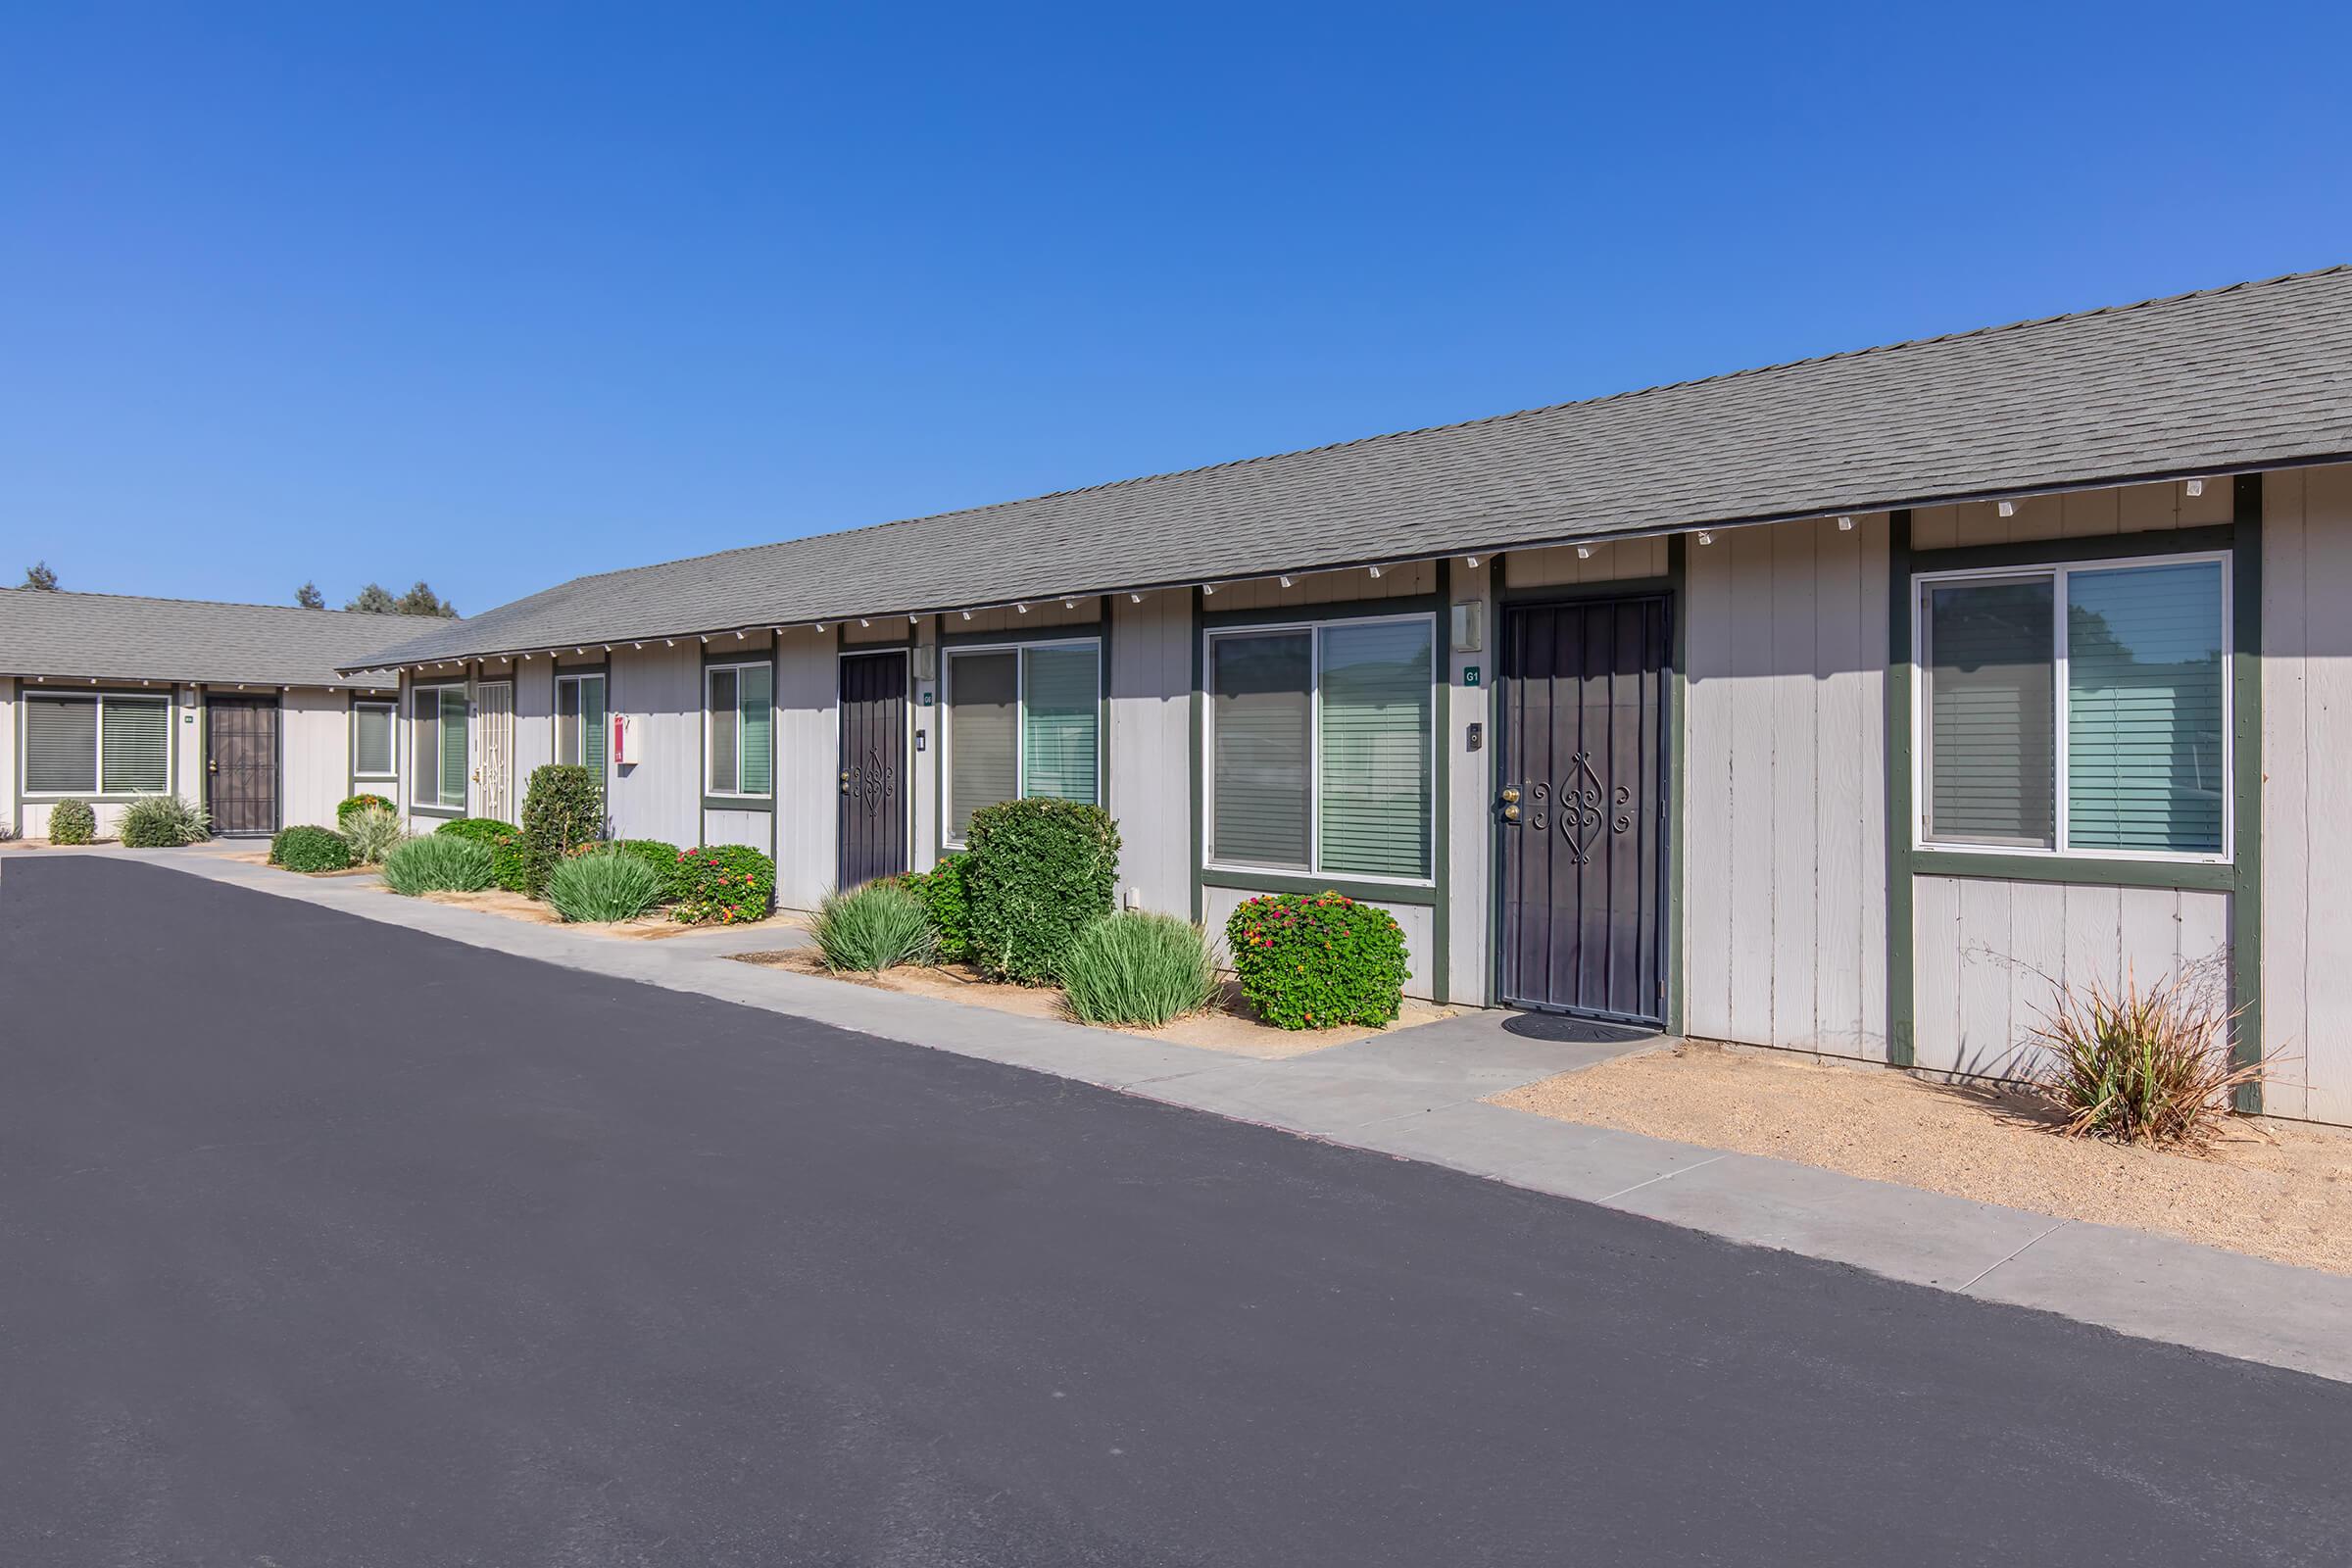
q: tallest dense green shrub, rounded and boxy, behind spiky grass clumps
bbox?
[964,800,1119,985]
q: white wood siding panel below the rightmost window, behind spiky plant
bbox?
[1912,877,2230,1079]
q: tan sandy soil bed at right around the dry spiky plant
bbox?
[1494,1042,2352,1274]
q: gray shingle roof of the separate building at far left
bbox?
[0,588,416,686]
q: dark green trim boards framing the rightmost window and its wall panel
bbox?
[1886,496,2263,1112]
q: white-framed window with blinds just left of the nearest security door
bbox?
[1209,615,1437,882]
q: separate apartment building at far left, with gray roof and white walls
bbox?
[0,588,416,837]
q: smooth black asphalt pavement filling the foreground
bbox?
[0,851,2352,1568]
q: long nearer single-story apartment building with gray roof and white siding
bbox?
[348,268,2352,1121]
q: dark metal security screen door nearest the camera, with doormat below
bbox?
[1495,595,1672,1022]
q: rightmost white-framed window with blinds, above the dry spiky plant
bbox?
[1919,558,2230,856]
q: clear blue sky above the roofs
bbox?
[0,0,2352,612]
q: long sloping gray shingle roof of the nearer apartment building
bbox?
[357,268,2352,662]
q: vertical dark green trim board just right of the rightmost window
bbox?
[2230,472,2263,1116]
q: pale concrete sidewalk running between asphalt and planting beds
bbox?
[55,849,2352,1382]
